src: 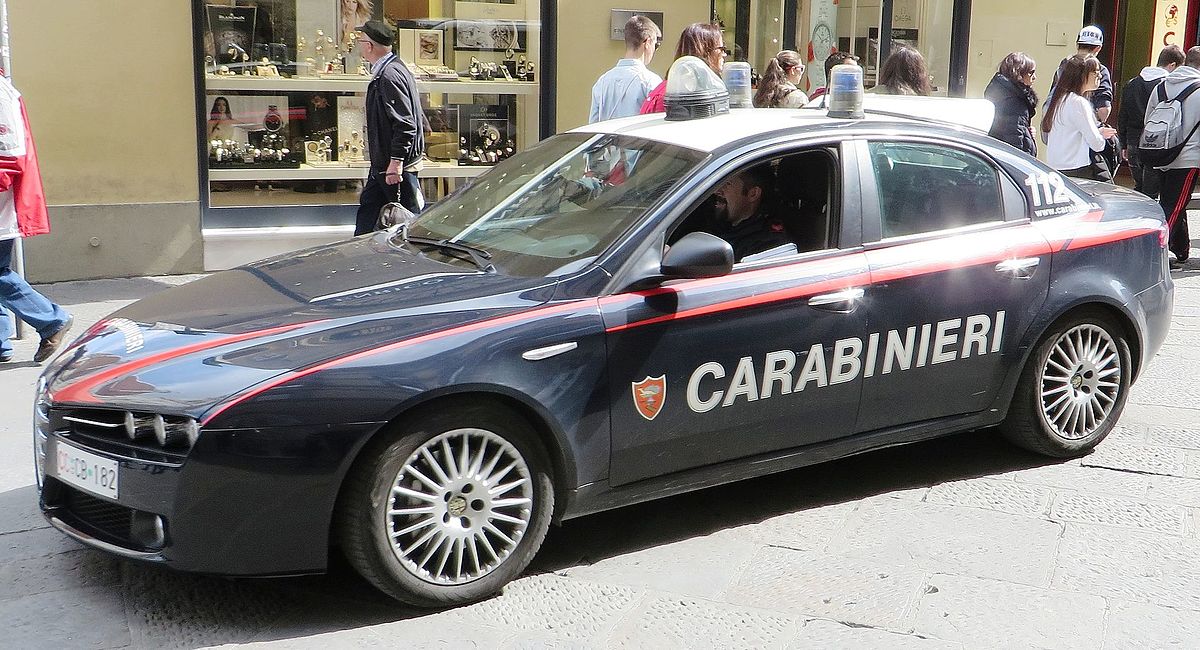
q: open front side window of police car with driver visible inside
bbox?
[667,148,838,263]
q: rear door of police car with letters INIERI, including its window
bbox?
[858,138,1050,432]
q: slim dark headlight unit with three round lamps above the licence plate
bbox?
[47,407,199,464]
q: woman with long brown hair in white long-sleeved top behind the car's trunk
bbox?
[1042,54,1116,182]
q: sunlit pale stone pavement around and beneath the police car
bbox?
[7,226,1200,650]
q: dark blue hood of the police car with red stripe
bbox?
[43,235,554,416]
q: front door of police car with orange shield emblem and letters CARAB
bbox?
[601,144,868,486]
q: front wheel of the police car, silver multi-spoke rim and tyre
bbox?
[336,404,554,608]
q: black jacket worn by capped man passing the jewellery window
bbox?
[366,56,425,175]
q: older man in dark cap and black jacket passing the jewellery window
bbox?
[354,20,425,235]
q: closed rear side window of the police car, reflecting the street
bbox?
[869,142,1004,239]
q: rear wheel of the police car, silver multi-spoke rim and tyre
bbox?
[1000,309,1132,458]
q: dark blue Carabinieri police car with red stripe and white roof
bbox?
[35,58,1174,607]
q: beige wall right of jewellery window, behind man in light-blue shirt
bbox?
[556,0,710,132]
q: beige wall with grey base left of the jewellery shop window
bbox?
[8,0,202,282]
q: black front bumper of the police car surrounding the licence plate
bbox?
[38,423,379,576]
